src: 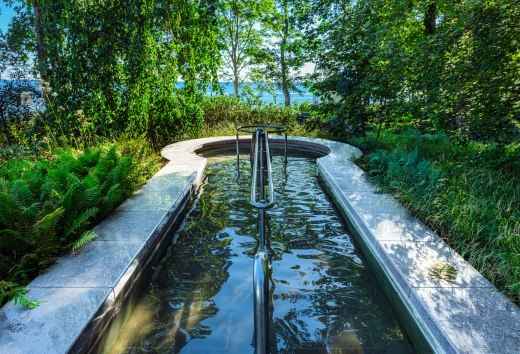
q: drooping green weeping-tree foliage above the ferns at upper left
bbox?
[0,0,220,150]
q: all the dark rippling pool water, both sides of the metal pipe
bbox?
[112,157,413,353]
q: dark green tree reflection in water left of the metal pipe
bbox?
[130,171,232,353]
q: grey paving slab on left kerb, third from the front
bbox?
[93,211,166,241]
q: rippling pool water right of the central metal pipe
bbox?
[270,160,409,353]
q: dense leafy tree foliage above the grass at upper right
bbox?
[307,0,520,144]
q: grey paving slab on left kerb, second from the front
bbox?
[31,240,146,288]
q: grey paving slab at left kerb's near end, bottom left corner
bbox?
[0,288,113,354]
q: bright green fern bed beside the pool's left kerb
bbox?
[0,139,161,306]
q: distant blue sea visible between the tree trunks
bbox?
[0,80,318,105]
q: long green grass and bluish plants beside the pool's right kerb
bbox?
[365,132,520,302]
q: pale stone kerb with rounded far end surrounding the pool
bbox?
[0,136,520,353]
